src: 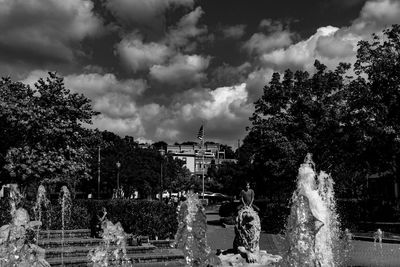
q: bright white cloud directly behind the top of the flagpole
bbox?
[158,83,253,142]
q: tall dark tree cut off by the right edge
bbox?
[349,25,400,195]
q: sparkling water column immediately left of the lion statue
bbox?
[175,192,216,266]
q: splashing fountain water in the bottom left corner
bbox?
[0,185,50,267]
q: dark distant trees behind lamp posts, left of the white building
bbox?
[81,131,190,198]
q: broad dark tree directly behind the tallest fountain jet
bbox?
[244,61,350,199]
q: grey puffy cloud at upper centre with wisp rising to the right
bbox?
[116,7,209,74]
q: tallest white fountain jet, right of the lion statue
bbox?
[282,154,347,266]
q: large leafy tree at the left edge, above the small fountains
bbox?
[0,73,98,192]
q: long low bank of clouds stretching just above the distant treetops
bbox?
[19,70,253,143]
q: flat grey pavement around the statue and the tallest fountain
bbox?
[207,210,400,267]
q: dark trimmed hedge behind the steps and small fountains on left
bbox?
[0,199,178,239]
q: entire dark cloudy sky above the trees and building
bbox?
[0,0,400,147]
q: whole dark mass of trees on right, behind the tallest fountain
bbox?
[239,25,400,201]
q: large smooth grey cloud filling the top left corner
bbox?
[0,0,102,63]
